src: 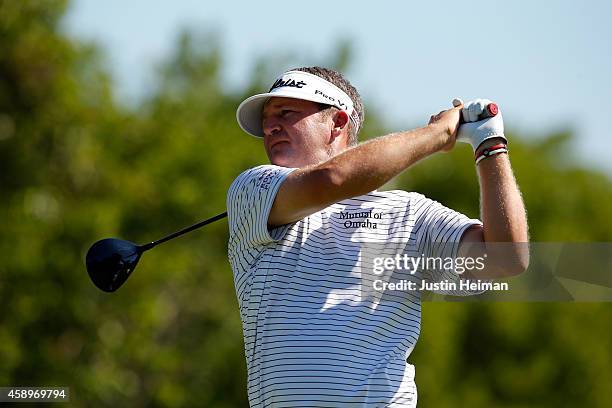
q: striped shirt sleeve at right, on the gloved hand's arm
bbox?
[415,194,483,296]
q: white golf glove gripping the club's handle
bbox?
[453,98,507,152]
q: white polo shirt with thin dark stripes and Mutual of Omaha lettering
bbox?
[227,165,480,408]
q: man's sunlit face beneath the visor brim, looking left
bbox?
[262,97,346,167]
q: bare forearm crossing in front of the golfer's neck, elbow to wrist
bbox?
[317,124,448,198]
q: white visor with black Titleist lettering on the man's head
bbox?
[236,71,360,137]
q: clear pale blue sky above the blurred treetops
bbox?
[64,0,612,176]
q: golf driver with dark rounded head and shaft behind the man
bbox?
[85,212,227,292]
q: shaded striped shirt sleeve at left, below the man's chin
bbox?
[227,165,295,248]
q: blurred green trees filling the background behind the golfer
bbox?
[0,0,612,407]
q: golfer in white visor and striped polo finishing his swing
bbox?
[227,67,528,408]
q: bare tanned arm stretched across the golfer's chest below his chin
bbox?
[268,106,461,226]
